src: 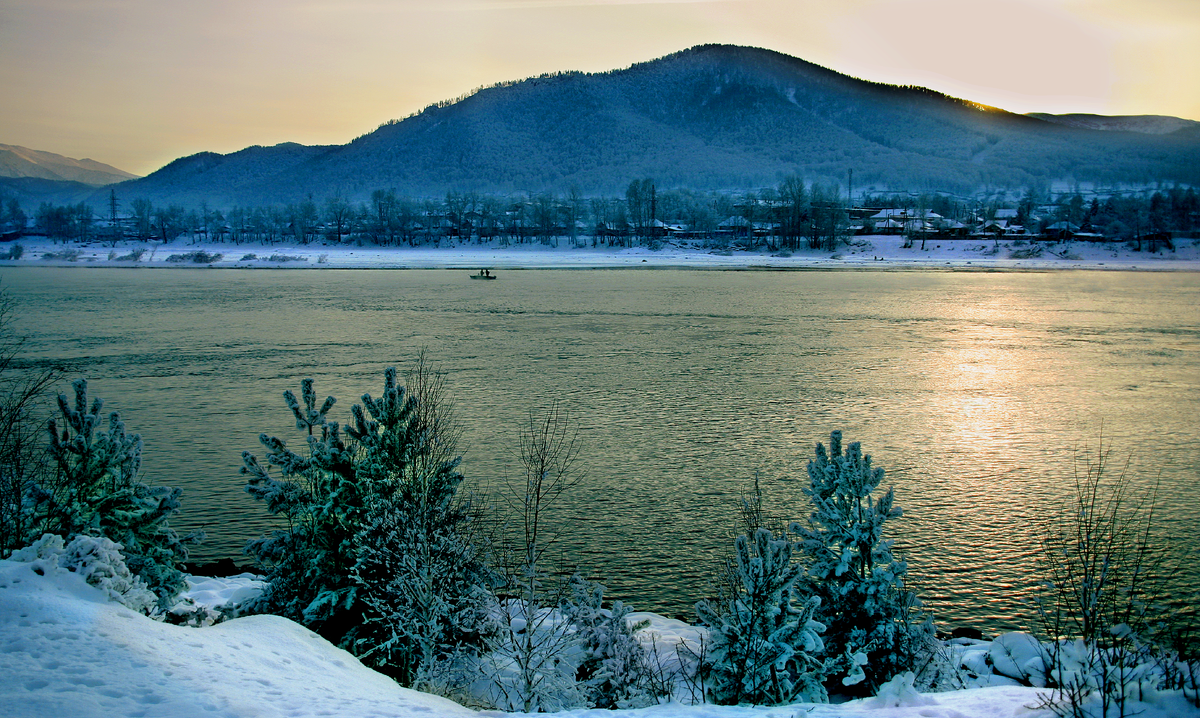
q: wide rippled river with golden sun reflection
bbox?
[2,268,1200,630]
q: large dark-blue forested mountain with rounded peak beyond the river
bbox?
[100,46,1200,207]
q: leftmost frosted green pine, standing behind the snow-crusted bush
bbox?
[28,379,200,609]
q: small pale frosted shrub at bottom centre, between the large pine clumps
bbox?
[559,574,655,708]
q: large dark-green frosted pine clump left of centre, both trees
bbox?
[242,363,493,684]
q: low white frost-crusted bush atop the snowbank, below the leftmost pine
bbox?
[10,533,158,615]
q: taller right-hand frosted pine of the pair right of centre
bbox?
[790,431,932,690]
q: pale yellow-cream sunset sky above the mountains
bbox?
[0,0,1200,174]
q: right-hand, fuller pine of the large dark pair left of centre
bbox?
[347,370,496,687]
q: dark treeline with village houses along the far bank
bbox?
[0,176,1200,251]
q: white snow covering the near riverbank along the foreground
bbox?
[0,560,1200,718]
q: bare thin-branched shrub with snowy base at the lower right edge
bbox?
[1034,443,1200,718]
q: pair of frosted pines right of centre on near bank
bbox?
[696,431,934,704]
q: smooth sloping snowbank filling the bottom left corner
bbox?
[0,561,475,718]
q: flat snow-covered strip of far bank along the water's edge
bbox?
[7,235,1200,271]
